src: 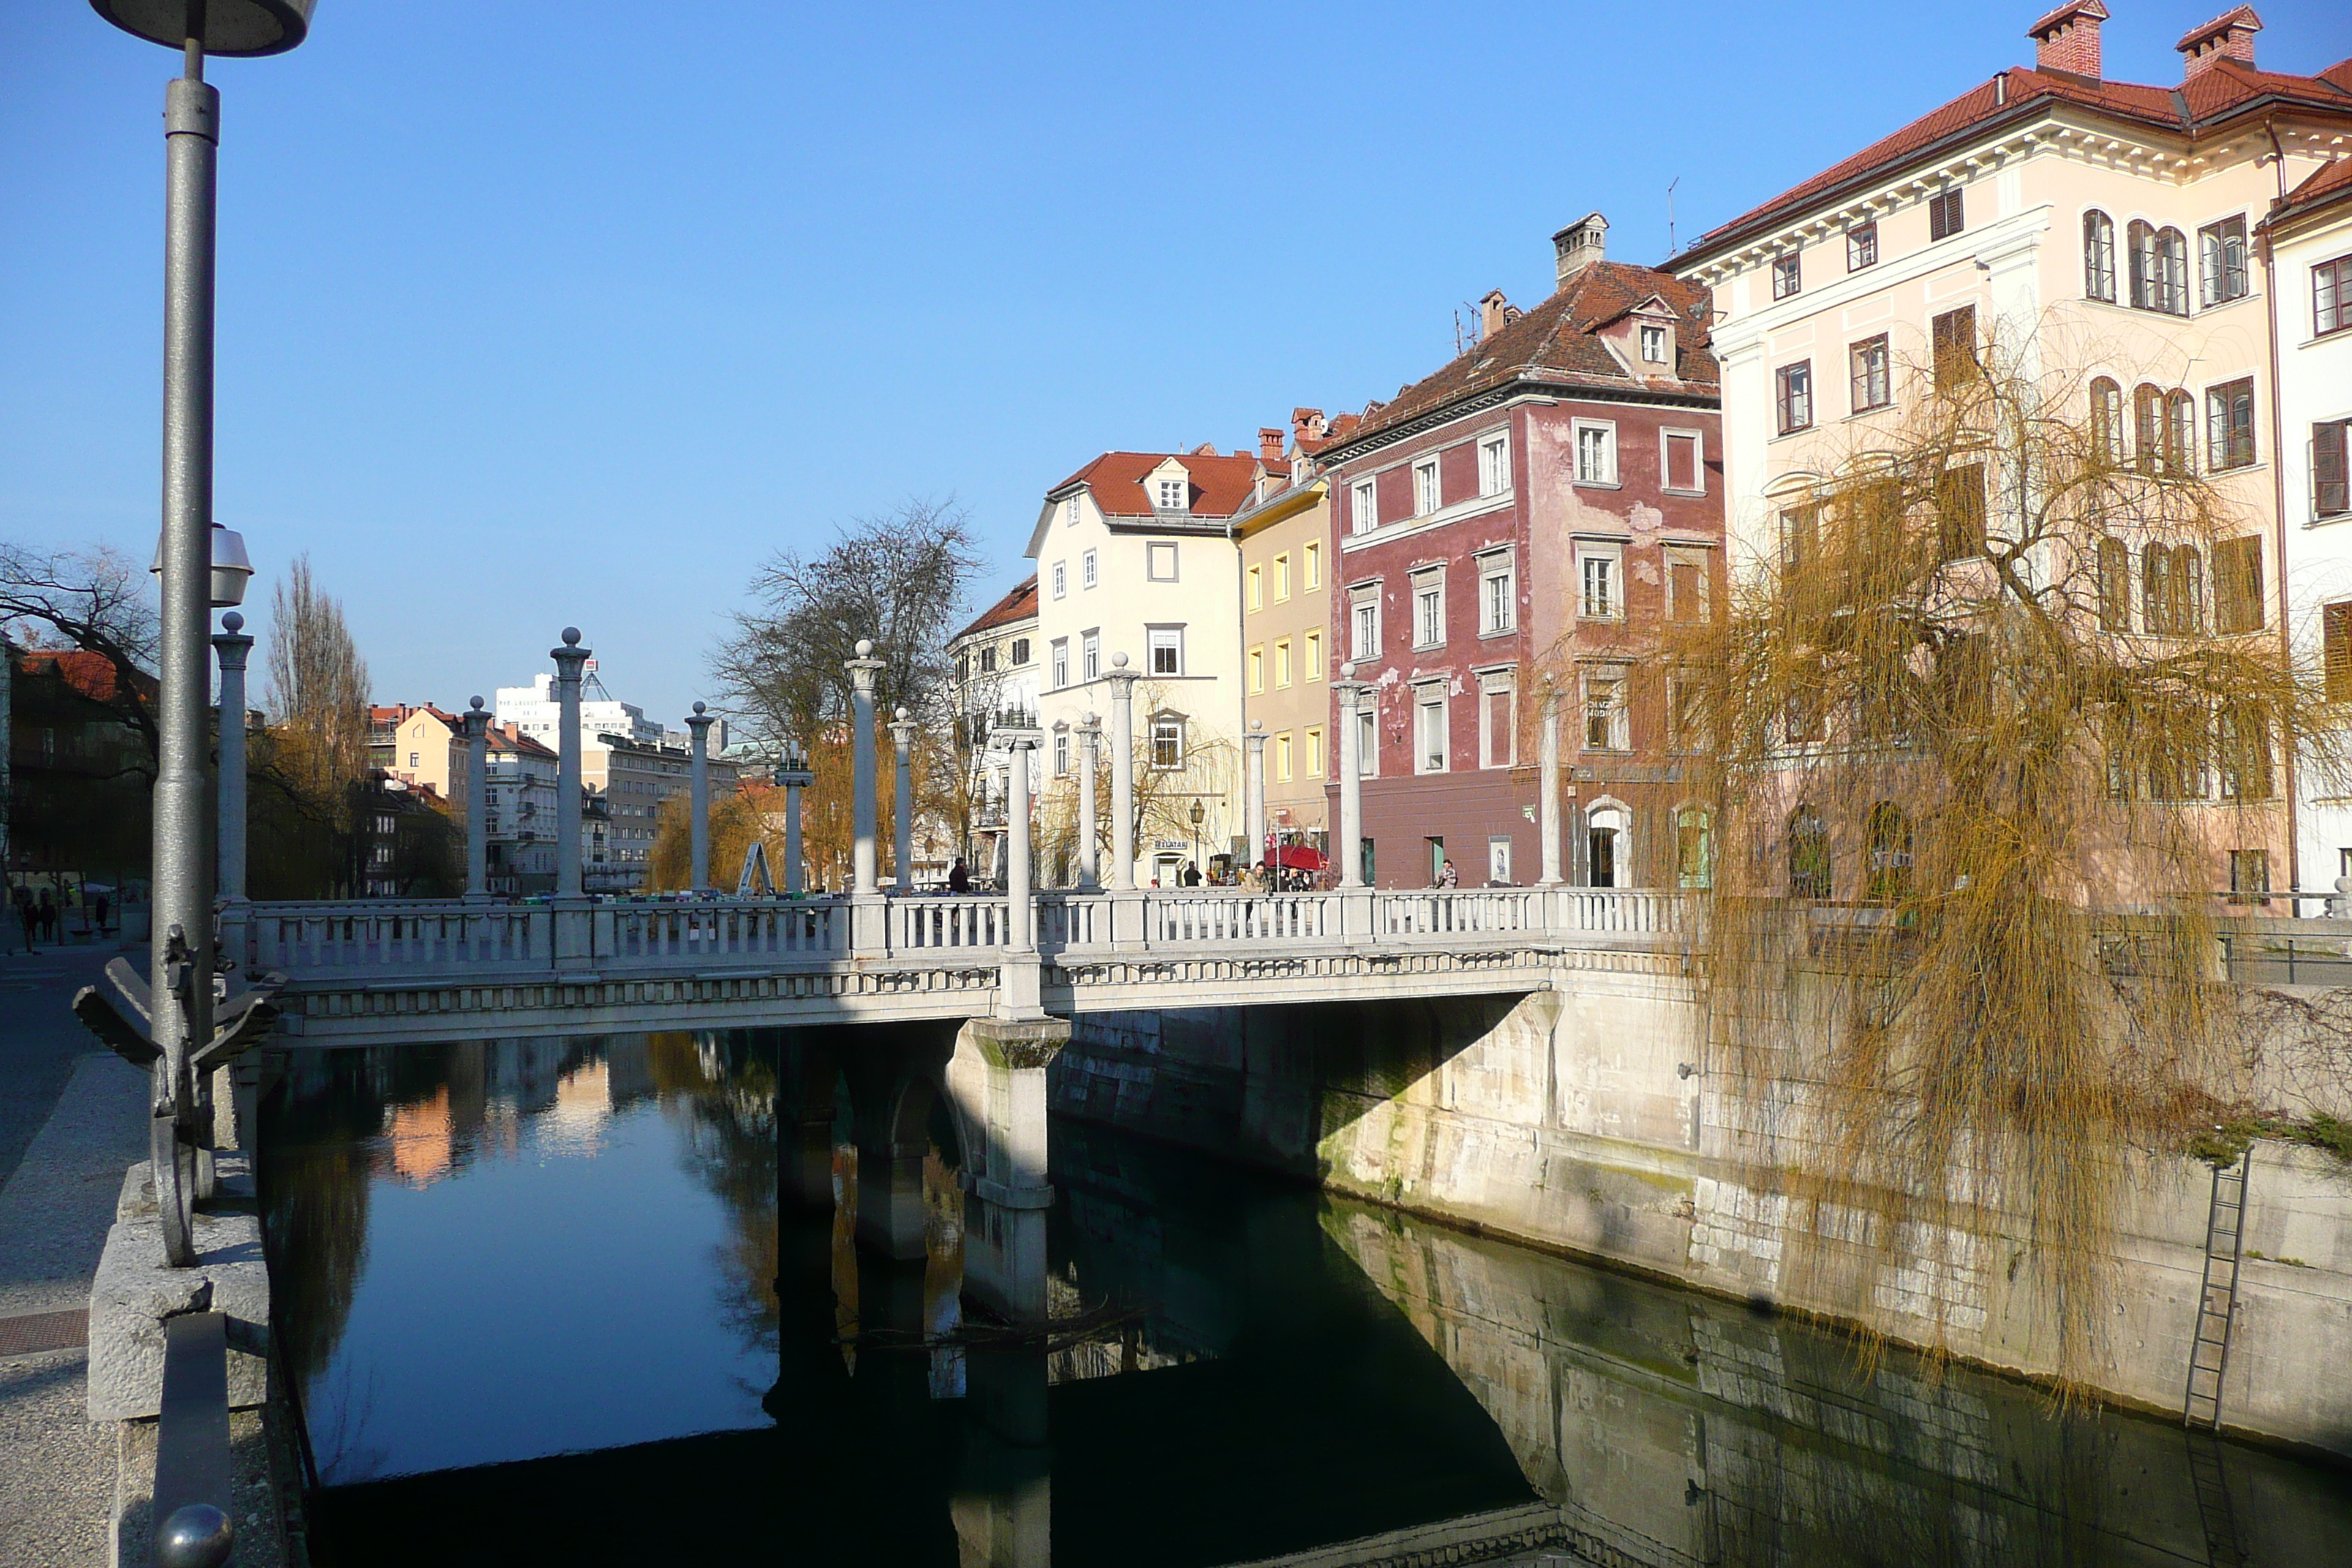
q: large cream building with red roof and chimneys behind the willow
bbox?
[1673,0,2352,889]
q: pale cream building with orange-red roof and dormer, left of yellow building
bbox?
[1028,447,1261,886]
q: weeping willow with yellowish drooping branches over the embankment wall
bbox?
[1673,333,2340,1384]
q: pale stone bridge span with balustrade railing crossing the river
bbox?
[224,886,1691,1046]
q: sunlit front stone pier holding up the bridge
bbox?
[948,1018,1070,1324]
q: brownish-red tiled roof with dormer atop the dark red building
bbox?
[1324,261,1717,451]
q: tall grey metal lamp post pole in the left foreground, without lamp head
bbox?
[148,37,221,1267]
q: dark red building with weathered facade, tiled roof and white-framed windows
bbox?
[1317,214,1724,886]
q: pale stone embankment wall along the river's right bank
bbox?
[1054,971,2352,1455]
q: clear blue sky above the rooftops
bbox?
[0,0,2352,722]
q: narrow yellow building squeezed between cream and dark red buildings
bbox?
[1232,456,1336,860]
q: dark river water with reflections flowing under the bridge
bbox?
[261,1034,2352,1568]
